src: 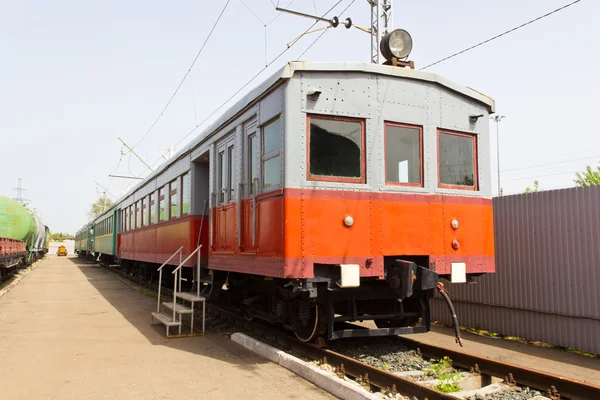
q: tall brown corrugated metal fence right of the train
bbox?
[432,186,600,353]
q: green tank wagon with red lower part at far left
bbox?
[0,197,50,278]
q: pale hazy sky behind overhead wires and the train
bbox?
[0,0,600,233]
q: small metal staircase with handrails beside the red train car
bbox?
[152,245,206,338]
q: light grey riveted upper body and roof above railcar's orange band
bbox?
[94,62,494,218]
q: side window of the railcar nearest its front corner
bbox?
[261,117,281,189]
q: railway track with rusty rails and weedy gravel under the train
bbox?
[96,263,600,400]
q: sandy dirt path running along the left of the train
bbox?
[0,255,333,400]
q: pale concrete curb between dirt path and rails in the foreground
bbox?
[231,332,381,400]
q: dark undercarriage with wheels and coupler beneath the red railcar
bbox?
[96,257,460,343]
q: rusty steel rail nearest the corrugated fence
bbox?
[400,337,600,400]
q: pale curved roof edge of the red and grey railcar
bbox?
[92,61,495,222]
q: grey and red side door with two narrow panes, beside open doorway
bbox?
[213,136,237,253]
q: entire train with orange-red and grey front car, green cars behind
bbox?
[78,44,495,341]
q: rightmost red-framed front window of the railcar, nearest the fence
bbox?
[438,130,477,190]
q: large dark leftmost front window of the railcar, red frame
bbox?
[308,115,366,183]
